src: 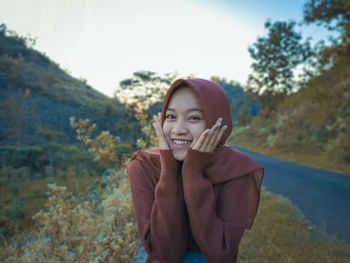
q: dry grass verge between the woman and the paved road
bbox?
[238,190,350,263]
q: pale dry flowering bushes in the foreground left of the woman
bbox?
[2,168,139,262]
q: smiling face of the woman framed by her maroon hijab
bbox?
[163,87,206,161]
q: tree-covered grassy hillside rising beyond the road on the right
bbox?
[229,0,350,174]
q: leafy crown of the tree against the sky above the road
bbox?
[247,21,312,97]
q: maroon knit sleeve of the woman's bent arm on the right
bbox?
[182,149,249,263]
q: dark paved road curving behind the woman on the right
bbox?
[233,146,350,244]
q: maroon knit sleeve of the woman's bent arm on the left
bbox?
[128,150,189,262]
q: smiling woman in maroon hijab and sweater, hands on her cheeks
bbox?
[128,79,263,263]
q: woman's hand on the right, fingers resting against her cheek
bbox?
[192,117,227,152]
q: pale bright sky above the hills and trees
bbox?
[0,0,330,96]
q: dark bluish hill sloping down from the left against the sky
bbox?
[0,24,135,145]
